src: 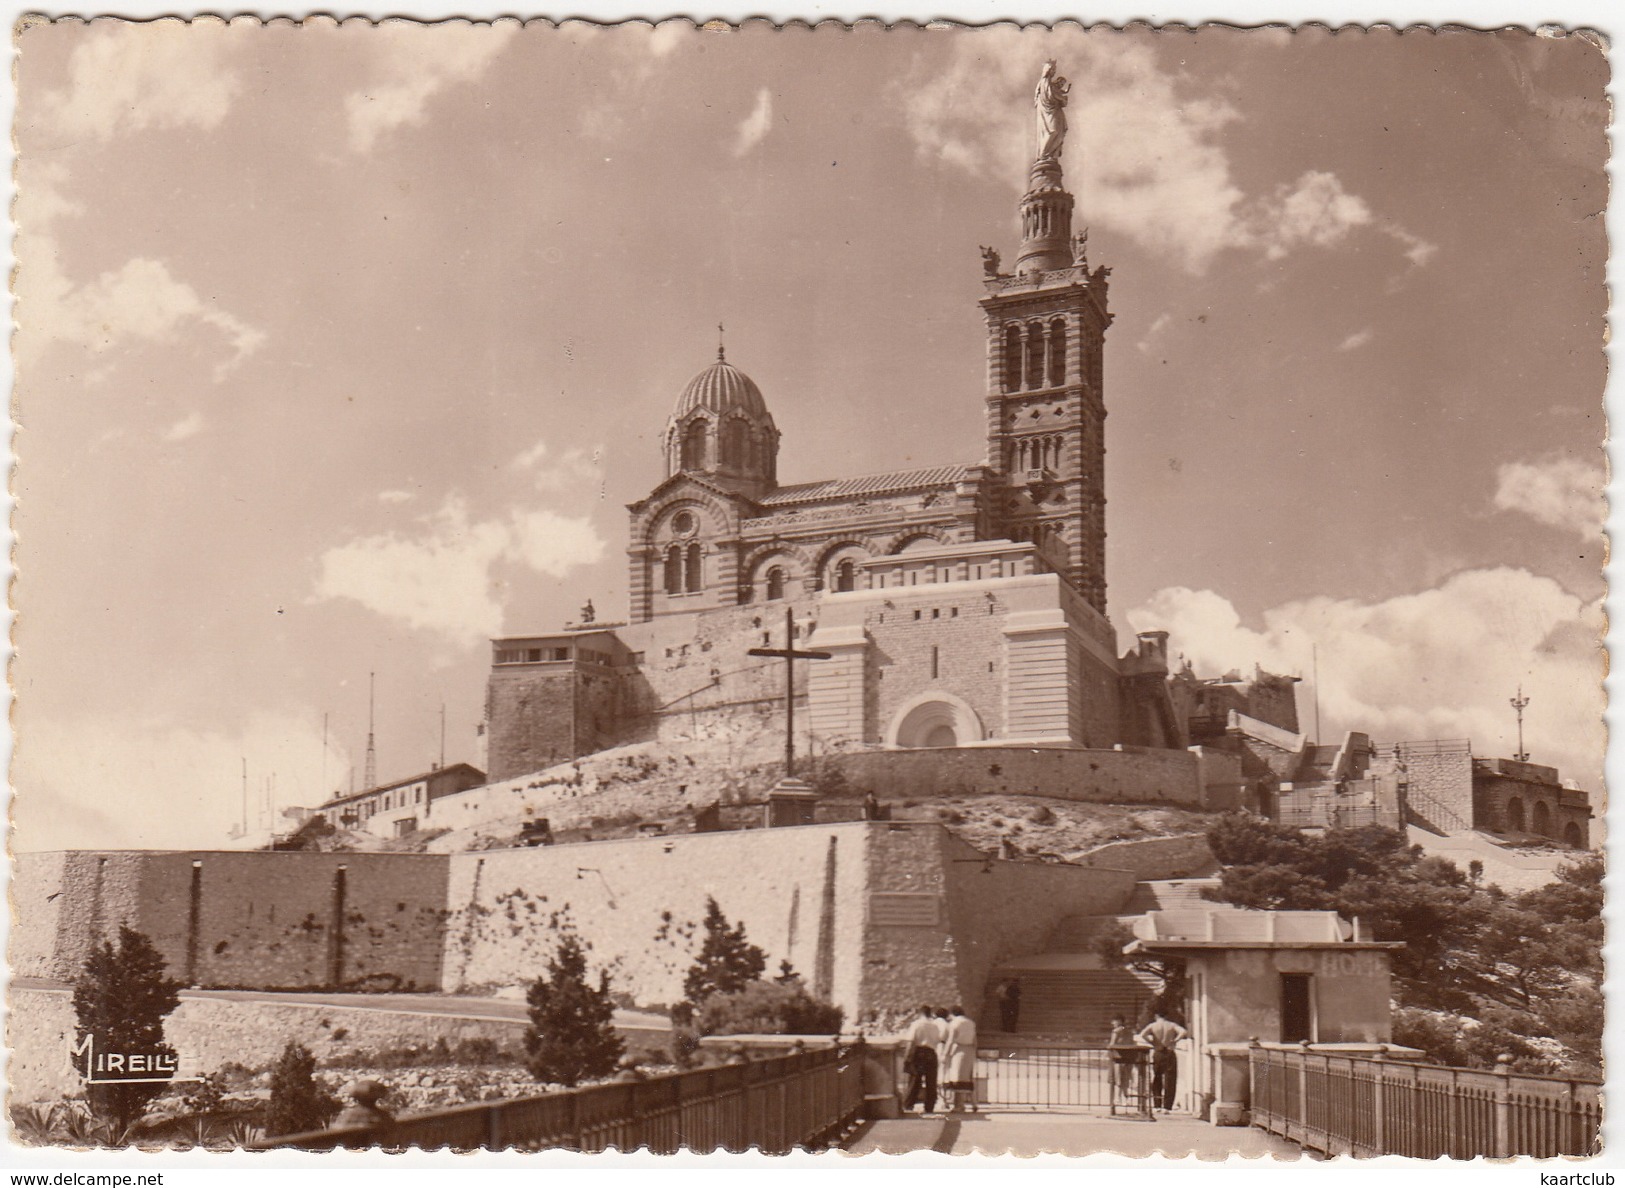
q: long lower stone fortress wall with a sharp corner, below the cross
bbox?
[10,822,1155,1021]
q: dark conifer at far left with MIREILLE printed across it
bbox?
[73,925,180,1133]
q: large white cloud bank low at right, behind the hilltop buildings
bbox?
[1126,567,1606,788]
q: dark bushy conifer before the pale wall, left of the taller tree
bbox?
[525,934,626,1087]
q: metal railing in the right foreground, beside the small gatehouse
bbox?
[1248,1048,1602,1159]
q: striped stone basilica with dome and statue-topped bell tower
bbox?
[486,75,1297,780]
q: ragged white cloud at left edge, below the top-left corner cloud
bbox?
[40,257,265,382]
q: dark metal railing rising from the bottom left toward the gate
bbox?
[260,1043,863,1155]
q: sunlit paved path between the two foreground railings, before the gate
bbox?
[848,1110,1305,1159]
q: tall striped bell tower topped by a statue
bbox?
[980,62,1112,614]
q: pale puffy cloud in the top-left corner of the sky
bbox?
[37,18,245,143]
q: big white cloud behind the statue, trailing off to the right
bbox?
[895,29,1430,271]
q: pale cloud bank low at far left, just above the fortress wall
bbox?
[11,710,349,850]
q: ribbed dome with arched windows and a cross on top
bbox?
[666,346,778,492]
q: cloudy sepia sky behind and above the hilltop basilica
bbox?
[13,21,1606,850]
